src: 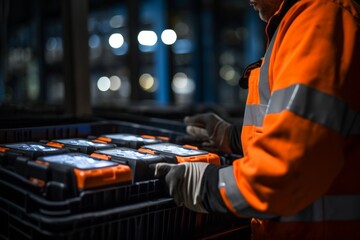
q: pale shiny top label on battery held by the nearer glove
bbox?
[141,143,208,157]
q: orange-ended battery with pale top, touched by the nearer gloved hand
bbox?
[139,143,220,165]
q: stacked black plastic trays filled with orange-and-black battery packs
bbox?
[0,121,249,240]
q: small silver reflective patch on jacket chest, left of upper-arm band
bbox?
[243,104,268,127]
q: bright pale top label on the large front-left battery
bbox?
[41,154,118,170]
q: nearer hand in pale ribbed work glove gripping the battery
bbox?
[155,162,209,213]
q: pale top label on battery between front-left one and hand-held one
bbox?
[97,148,159,160]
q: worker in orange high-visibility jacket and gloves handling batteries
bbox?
[156,0,360,240]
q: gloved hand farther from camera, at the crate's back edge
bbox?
[177,113,231,153]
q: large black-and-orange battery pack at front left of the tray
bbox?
[22,153,131,199]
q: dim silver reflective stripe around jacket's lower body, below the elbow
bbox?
[279,195,360,222]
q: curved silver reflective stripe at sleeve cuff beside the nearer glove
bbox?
[219,166,275,219]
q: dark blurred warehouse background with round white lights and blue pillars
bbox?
[0,0,266,127]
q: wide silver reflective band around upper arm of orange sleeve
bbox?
[267,84,360,136]
